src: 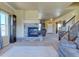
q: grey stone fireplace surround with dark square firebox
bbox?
[24,23,42,41]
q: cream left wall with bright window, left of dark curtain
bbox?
[0,10,9,48]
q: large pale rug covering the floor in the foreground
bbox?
[1,46,58,57]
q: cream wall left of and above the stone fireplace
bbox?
[16,10,40,38]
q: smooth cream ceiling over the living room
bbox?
[7,2,72,19]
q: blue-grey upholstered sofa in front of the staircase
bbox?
[58,38,79,57]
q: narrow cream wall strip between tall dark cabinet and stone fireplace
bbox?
[16,11,24,37]
